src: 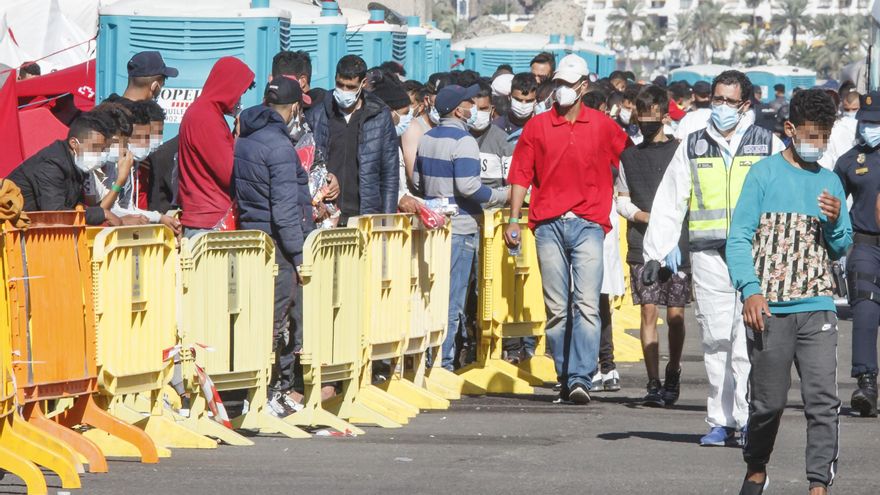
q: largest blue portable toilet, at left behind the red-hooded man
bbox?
[96,0,290,140]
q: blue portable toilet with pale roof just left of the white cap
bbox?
[452,33,558,77]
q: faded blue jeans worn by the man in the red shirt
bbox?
[535,218,605,390]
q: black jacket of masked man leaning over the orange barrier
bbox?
[8,139,105,225]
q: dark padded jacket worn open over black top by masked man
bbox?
[306,92,400,215]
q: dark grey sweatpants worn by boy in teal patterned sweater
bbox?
[743,311,840,486]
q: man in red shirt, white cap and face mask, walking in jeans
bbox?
[504,55,630,404]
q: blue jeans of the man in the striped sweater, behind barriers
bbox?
[441,234,480,371]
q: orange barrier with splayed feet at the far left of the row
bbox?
[4,211,158,473]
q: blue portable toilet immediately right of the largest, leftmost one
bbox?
[282,0,348,89]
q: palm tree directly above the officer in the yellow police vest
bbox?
[677,0,737,63]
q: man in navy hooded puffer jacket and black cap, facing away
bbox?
[232,76,314,416]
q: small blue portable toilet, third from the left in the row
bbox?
[346,10,406,67]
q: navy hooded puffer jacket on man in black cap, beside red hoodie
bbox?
[232,105,314,266]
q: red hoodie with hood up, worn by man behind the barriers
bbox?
[178,57,254,229]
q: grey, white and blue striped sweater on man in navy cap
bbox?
[413,119,507,234]
